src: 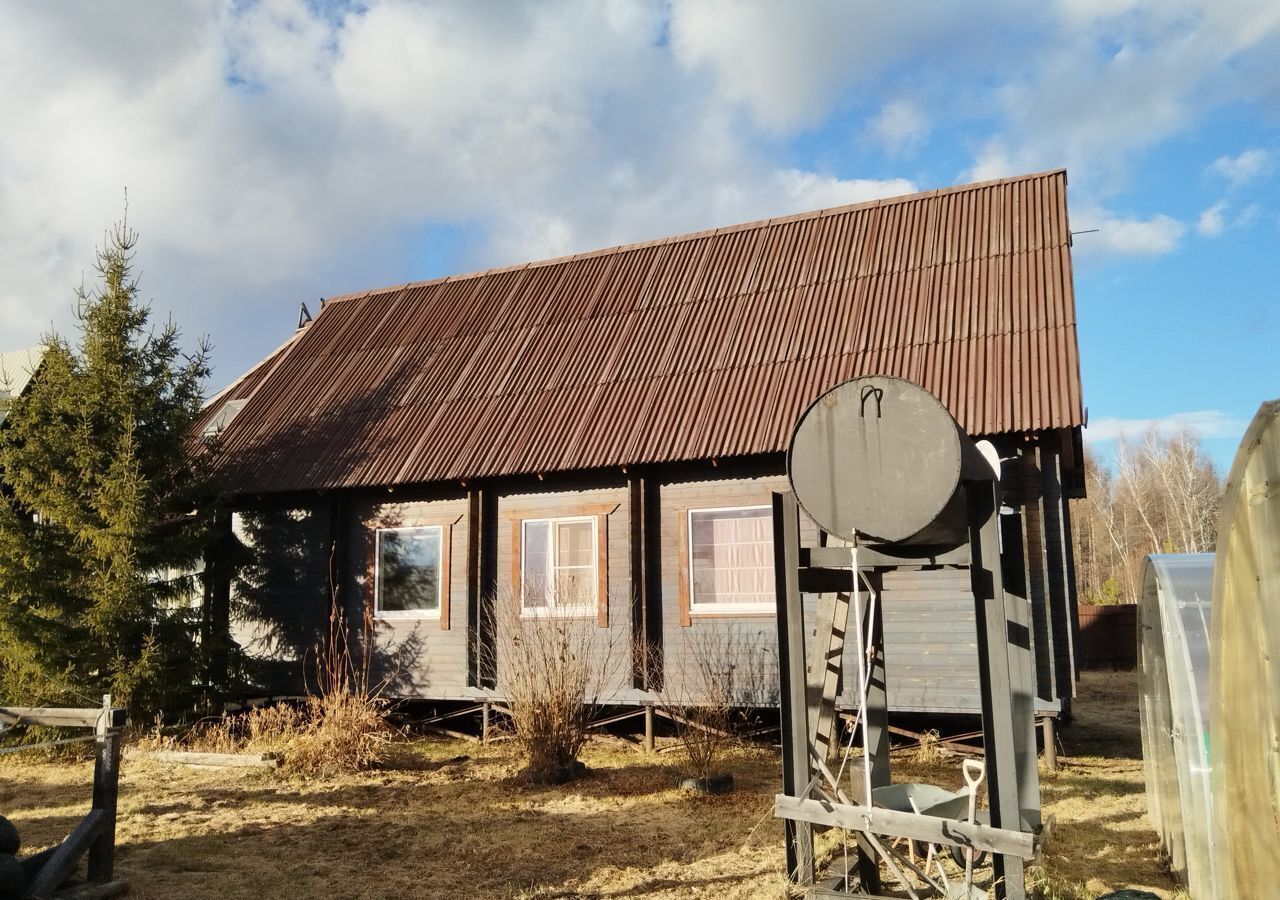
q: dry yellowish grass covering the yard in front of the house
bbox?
[0,675,1176,900]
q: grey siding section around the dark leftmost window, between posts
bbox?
[343,498,471,699]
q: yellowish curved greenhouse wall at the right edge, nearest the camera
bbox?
[1210,401,1280,897]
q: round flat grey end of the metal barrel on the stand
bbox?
[787,375,972,543]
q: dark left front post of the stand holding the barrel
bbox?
[773,493,814,887]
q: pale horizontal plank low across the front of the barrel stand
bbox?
[773,794,1037,859]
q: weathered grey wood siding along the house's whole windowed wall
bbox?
[225,460,1073,713]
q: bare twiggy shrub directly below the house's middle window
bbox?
[490,585,628,783]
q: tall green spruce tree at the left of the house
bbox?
[0,219,210,716]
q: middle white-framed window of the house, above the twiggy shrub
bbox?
[520,516,599,615]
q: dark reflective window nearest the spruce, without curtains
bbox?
[374,525,444,618]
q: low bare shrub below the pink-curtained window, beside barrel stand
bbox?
[659,629,777,778]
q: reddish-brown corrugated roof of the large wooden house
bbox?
[209,170,1084,493]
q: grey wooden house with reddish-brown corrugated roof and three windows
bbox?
[205,170,1084,713]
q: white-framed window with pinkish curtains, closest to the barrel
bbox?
[689,506,776,613]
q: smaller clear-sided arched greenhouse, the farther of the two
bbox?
[1138,553,1228,900]
